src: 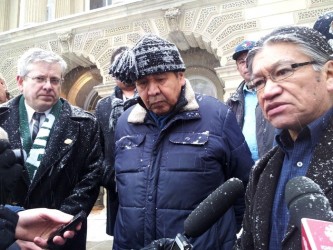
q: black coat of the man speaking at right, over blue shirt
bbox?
[235,118,333,250]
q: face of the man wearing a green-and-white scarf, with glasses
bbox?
[17,62,62,112]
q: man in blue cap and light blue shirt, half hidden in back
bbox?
[226,40,274,161]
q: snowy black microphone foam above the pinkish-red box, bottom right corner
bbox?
[285,176,333,230]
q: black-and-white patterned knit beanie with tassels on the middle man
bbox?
[109,34,186,82]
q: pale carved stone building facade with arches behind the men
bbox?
[0,0,333,111]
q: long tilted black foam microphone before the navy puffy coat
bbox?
[184,178,244,238]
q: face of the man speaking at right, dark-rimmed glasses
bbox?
[252,43,333,138]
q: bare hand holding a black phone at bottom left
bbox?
[15,208,82,248]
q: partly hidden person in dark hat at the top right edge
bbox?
[313,11,333,48]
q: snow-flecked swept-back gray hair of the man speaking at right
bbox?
[246,26,333,75]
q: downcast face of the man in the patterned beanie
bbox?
[136,72,185,115]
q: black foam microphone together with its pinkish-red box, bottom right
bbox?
[285,176,333,250]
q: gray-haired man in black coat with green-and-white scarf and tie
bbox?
[0,48,103,249]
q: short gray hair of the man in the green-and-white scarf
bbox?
[17,48,67,77]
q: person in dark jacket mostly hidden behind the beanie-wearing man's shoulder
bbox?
[95,47,137,235]
